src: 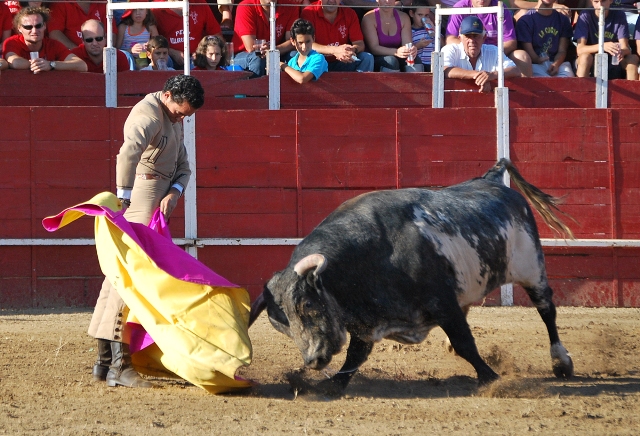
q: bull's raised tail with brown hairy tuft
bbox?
[483,158,575,239]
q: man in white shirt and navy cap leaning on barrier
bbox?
[442,15,520,92]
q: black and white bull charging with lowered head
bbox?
[250,159,573,393]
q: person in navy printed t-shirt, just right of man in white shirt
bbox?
[516,0,575,77]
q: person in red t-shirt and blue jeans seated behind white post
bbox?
[233,0,300,76]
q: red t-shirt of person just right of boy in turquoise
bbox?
[301,1,364,62]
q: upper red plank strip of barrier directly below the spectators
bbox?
[6,70,640,109]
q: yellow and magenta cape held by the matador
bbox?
[42,192,251,393]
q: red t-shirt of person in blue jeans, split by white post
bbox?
[233,0,300,53]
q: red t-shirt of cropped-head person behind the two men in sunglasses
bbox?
[47,1,107,45]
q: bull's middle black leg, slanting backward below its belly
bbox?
[437,301,499,385]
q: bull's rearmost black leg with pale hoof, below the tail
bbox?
[524,283,573,378]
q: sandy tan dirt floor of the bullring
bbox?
[0,308,640,436]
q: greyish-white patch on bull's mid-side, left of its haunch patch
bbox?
[413,206,489,306]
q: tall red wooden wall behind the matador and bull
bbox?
[0,102,640,308]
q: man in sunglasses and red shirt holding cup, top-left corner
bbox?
[2,7,87,74]
